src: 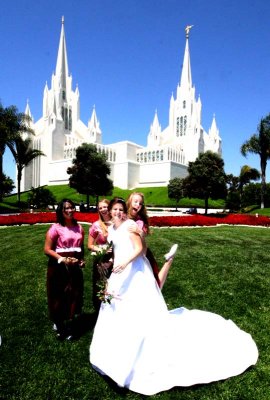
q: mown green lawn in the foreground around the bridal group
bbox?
[0,225,270,400]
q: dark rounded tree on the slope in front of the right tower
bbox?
[183,151,227,214]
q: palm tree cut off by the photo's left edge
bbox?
[0,103,31,201]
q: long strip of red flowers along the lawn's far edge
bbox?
[0,212,270,226]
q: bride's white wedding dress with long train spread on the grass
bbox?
[90,220,258,395]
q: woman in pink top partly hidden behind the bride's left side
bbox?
[88,199,112,313]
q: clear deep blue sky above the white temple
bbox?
[0,0,270,181]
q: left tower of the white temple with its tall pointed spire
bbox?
[24,17,87,190]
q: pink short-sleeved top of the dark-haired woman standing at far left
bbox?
[49,224,83,253]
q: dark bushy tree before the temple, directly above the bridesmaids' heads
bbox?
[67,143,113,209]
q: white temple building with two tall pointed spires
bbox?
[21,18,221,191]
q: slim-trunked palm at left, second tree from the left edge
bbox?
[10,136,45,205]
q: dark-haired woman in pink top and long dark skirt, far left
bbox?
[44,199,85,340]
